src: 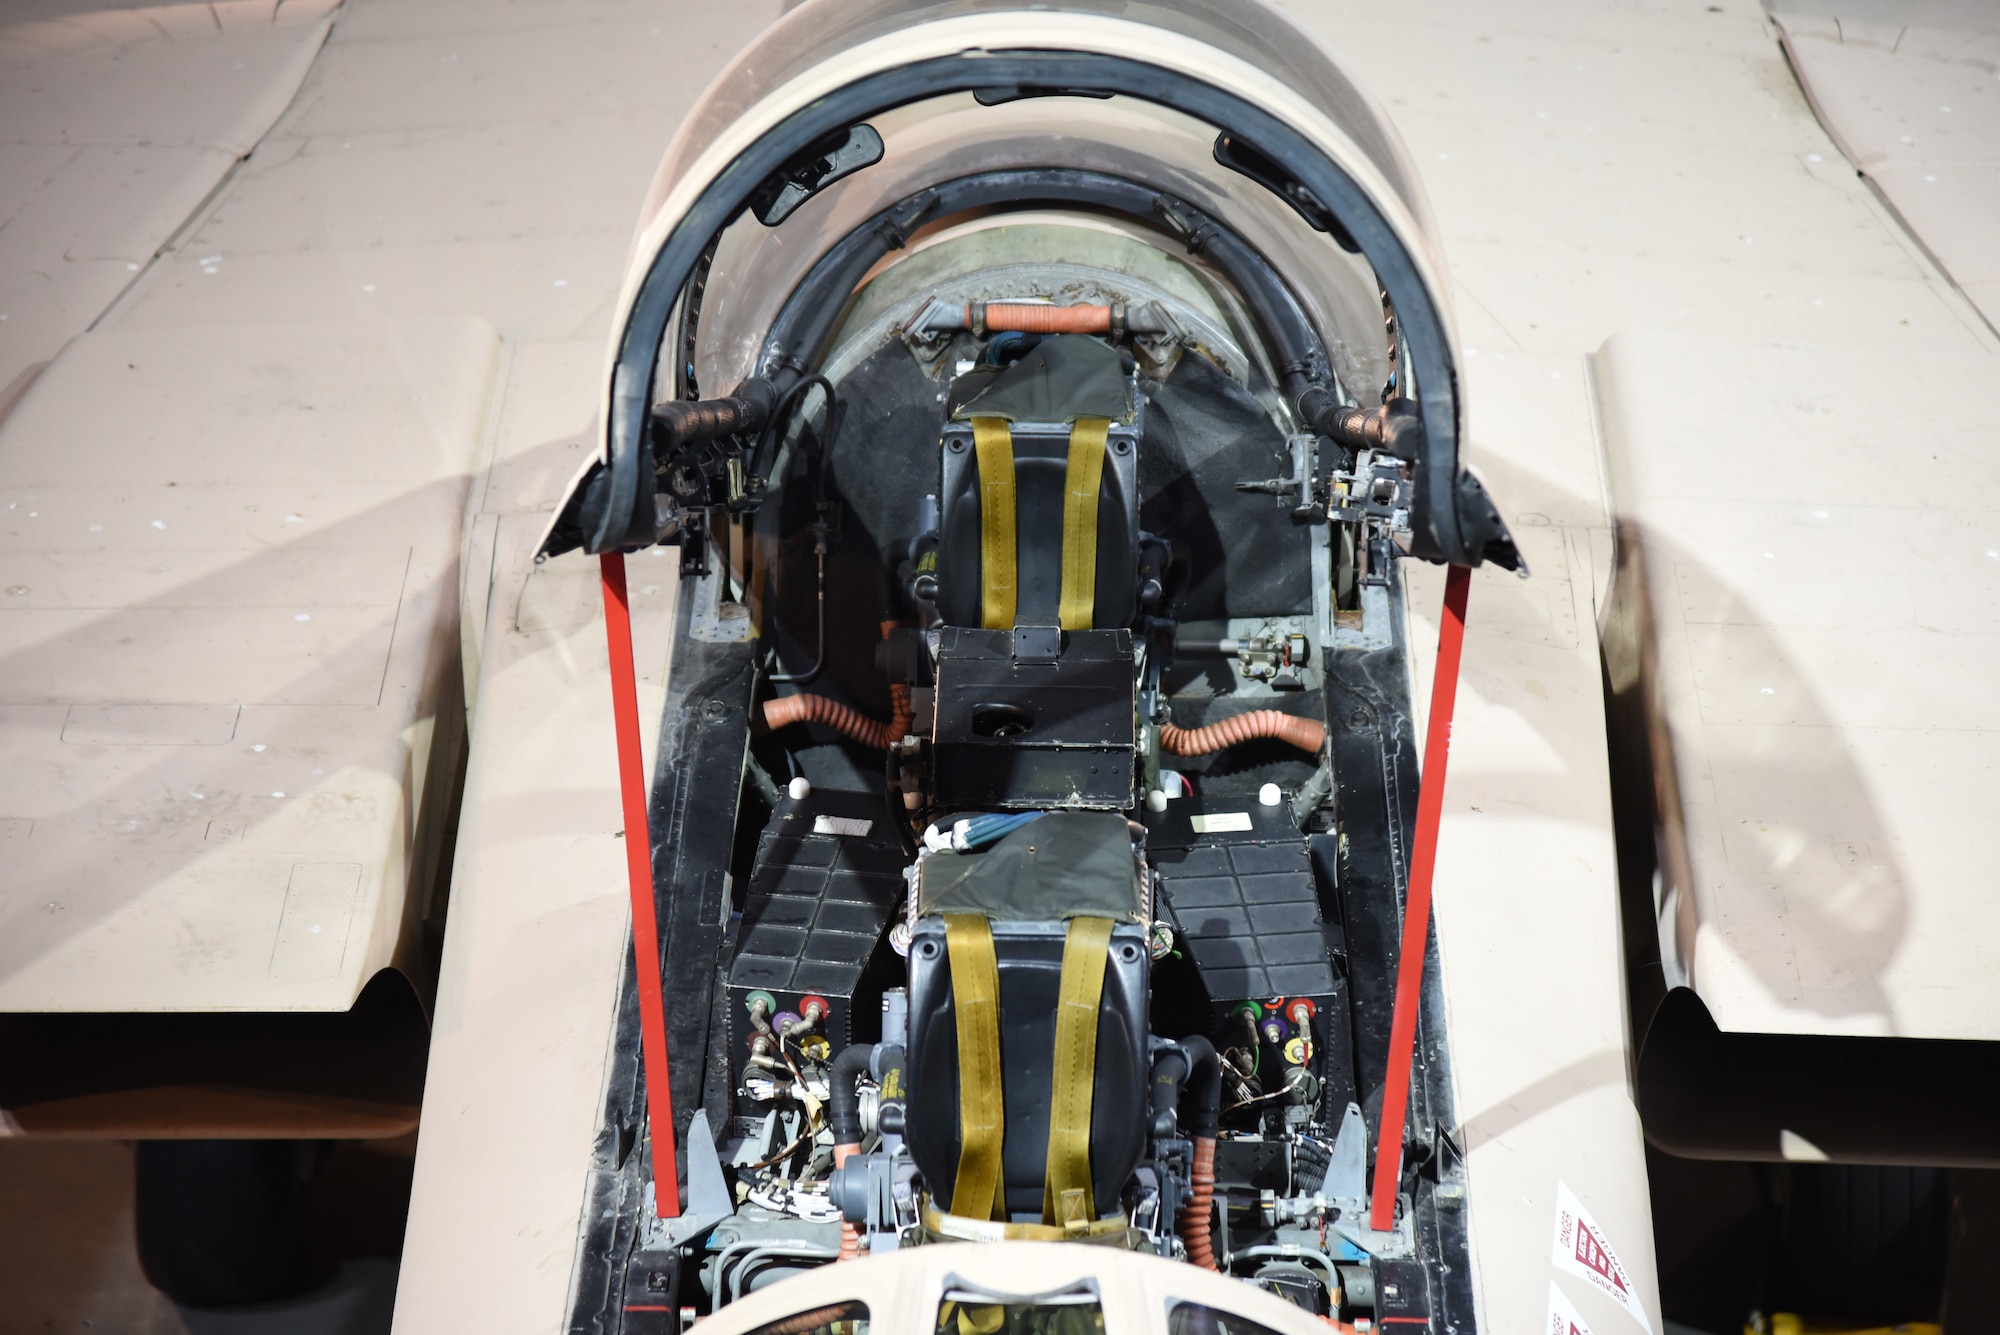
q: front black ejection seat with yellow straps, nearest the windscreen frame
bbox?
[908,811,1150,1241]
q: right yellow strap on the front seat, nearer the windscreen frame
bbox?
[1040,917,1112,1233]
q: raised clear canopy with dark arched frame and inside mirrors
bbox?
[544,0,1514,564]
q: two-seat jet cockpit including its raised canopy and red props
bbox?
[544,0,1520,1333]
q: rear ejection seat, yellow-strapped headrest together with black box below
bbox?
[916,334,1142,811]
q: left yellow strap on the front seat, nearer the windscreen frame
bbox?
[944,913,1006,1221]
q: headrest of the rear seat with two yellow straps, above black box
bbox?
[938,334,1138,630]
